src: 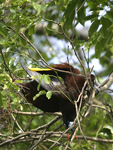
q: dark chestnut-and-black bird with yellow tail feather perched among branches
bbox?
[21,63,95,139]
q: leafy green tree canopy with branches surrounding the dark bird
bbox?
[0,0,113,150]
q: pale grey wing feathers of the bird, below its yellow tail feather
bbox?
[21,63,66,96]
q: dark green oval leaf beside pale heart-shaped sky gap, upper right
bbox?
[89,20,100,37]
